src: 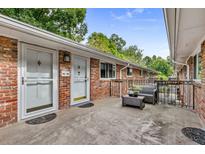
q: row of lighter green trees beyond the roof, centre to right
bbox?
[87,32,173,80]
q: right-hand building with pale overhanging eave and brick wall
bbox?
[164,8,205,120]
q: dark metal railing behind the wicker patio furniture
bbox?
[110,79,197,110]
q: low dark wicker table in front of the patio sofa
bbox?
[122,95,145,110]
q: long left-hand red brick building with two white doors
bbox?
[0,15,157,127]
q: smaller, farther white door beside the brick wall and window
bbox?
[71,56,90,105]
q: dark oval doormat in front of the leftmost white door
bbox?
[26,113,57,125]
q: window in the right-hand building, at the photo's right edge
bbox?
[194,53,202,79]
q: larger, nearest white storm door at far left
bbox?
[21,44,58,119]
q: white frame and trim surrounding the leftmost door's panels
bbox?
[18,42,58,120]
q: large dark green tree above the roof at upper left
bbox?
[0,8,87,42]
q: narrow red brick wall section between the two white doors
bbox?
[59,51,71,109]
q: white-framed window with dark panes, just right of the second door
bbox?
[100,63,116,78]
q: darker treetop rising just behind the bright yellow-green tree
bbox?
[110,34,126,51]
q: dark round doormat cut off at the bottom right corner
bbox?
[182,127,205,145]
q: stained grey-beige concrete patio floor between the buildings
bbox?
[0,98,203,144]
